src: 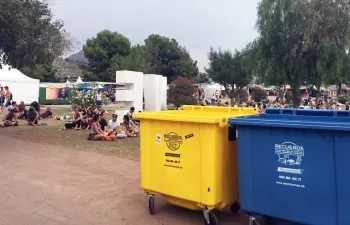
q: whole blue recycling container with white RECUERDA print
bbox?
[229,109,350,225]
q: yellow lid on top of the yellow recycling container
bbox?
[134,105,258,126]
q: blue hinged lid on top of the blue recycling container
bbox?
[229,108,350,131]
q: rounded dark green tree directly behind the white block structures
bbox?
[145,34,198,83]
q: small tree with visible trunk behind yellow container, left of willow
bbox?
[206,48,253,105]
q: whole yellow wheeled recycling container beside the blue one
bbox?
[135,106,258,225]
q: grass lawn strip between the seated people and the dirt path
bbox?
[0,108,140,161]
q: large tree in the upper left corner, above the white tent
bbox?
[0,0,73,69]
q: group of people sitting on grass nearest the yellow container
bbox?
[55,106,140,141]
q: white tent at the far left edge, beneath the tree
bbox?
[0,65,40,104]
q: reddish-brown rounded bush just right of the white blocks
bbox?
[168,77,197,106]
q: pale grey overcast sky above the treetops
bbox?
[51,0,259,71]
